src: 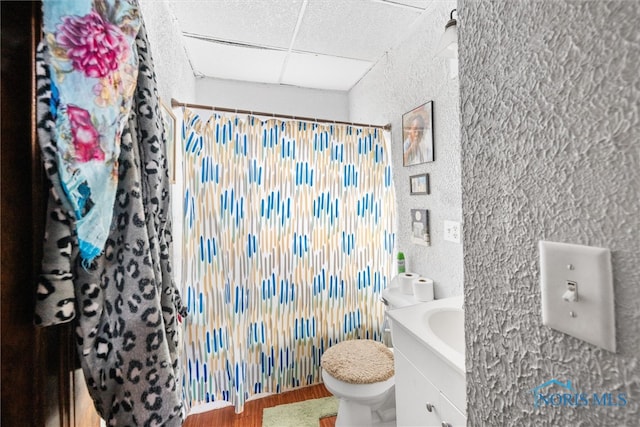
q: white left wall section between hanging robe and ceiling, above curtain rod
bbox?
[139,0,196,106]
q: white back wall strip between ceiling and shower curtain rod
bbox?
[196,78,349,121]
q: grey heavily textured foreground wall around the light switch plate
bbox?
[458,0,640,426]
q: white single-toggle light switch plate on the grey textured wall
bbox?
[539,241,616,353]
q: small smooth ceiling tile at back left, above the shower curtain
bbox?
[183,37,287,84]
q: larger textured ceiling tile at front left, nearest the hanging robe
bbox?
[170,0,303,49]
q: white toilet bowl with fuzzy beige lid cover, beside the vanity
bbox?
[320,339,396,427]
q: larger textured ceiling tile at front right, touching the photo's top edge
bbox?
[293,0,420,61]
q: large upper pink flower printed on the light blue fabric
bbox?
[56,11,129,78]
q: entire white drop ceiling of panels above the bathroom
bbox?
[169,0,432,91]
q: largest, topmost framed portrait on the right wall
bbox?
[402,101,434,166]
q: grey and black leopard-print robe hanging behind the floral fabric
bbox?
[35,20,186,426]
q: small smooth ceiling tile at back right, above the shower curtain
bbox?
[282,53,373,91]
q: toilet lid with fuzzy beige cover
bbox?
[320,340,394,384]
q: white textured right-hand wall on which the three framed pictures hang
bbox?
[349,1,462,298]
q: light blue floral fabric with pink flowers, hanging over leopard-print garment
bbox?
[43,0,140,262]
